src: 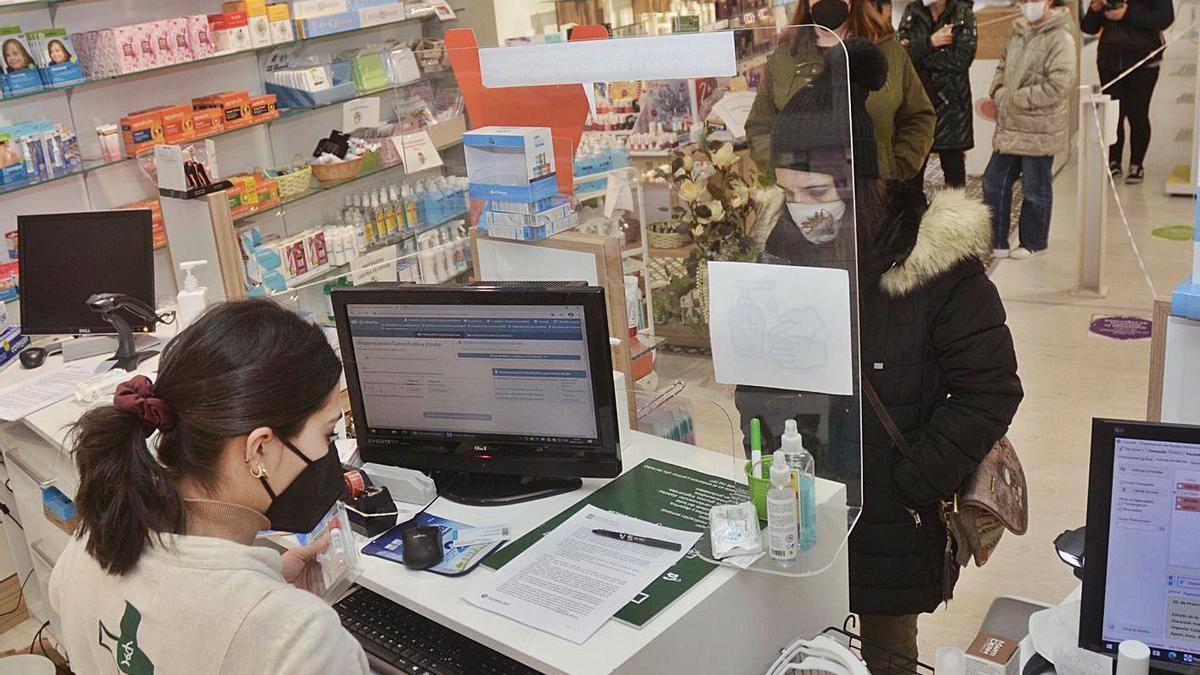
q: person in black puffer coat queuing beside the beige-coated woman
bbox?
[896,0,977,187]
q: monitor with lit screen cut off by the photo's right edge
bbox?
[1079,419,1200,675]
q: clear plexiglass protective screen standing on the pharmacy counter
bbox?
[251,22,874,577]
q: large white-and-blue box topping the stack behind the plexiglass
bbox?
[462,126,558,203]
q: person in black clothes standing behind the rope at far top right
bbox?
[1080,0,1175,185]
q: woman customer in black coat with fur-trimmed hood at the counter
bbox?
[736,41,1022,673]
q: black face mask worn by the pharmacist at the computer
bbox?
[259,438,346,533]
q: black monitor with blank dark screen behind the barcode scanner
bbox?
[17,209,155,335]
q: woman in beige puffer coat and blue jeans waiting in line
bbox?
[982,0,1076,259]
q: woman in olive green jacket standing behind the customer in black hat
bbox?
[746,0,937,180]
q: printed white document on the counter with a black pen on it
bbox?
[463,504,701,645]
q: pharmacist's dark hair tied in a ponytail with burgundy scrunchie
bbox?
[73,300,342,574]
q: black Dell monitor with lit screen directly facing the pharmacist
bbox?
[332,279,622,504]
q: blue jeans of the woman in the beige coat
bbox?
[983,153,1054,251]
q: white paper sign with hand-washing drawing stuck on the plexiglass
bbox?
[708,257,853,396]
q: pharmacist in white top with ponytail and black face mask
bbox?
[49,300,368,675]
